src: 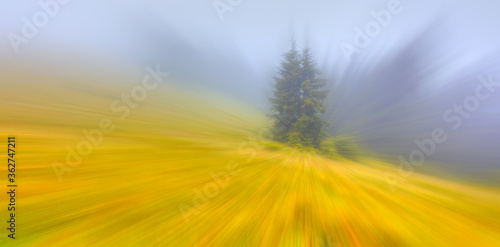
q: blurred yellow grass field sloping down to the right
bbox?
[0,74,500,247]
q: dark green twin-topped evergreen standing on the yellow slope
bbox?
[271,40,328,149]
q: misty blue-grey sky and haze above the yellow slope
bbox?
[0,0,500,172]
